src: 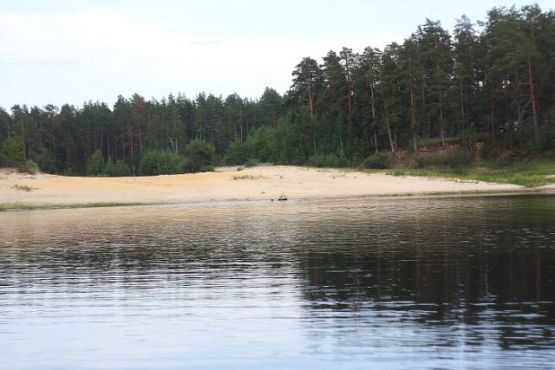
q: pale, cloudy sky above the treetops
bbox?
[0,0,554,111]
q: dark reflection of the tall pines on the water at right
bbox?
[300,196,555,349]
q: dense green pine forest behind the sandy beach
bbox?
[0,5,555,176]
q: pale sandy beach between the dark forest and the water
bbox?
[0,166,555,208]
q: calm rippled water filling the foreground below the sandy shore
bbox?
[0,195,555,369]
